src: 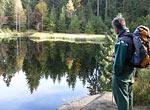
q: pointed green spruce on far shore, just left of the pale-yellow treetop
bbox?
[57,6,66,33]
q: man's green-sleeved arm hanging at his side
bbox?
[113,41,128,75]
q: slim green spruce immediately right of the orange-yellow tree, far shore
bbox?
[48,7,56,32]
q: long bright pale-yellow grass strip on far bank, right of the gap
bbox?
[30,33,105,44]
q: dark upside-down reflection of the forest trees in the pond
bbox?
[0,38,110,94]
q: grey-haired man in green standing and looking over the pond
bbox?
[112,17,134,110]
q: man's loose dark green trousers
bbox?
[112,73,133,110]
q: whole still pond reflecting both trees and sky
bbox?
[0,38,110,110]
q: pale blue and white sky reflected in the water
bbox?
[0,71,88,110]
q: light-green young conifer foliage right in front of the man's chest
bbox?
[96,35,117,80]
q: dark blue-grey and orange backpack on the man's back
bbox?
[131,26,150,68]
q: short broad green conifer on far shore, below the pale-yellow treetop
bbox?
[69,14,80,34]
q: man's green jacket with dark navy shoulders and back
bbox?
[113,29,134,75]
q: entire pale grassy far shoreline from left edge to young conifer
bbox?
[0,31,105,44]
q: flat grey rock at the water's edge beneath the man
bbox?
[58,92,150,110]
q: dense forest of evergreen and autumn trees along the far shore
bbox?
[0,0,150,34]
